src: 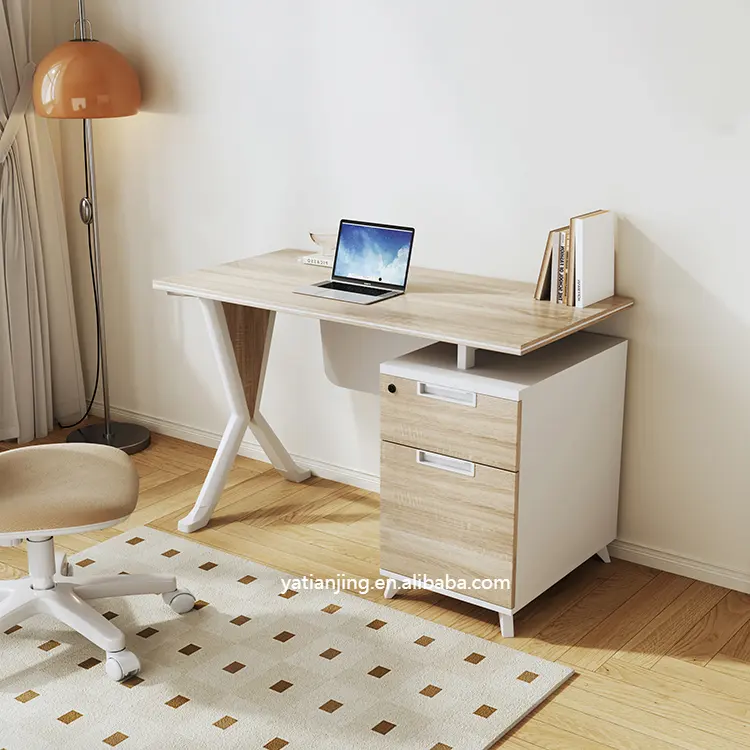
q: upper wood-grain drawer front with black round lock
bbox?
[380,375,519,471]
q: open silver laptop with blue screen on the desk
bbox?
[294,219,414,305]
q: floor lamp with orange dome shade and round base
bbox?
[34,0,151,453]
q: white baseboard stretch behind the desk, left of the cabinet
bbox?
[91,403,380,492]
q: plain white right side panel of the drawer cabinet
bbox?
[514,341,627,610]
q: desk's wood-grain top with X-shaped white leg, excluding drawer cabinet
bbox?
[154,250,633,532]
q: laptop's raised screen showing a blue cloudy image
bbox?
[333,220,414,289]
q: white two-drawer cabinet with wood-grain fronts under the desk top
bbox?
[380,333,627,636]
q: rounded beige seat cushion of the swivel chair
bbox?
[0,443,138,536]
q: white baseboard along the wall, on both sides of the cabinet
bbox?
[92,403,750,594]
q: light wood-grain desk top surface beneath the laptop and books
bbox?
[154,250,633,355]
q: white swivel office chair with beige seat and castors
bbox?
[0,443,195,681]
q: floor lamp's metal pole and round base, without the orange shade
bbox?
[67,0,151,453]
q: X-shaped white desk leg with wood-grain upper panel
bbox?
[177,299,310,533]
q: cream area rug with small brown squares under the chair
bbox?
[0,527,572,750]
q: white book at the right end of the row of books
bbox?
[570,211,617,307]
